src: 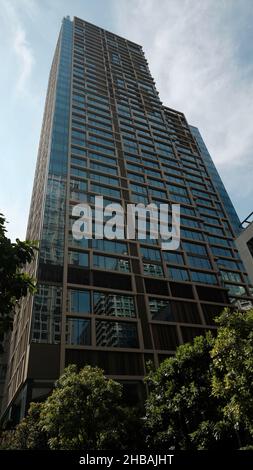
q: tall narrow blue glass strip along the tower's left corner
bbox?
[40,19,73,266]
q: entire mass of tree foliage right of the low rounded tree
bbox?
[145,310,253,450]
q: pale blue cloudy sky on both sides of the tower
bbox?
[0,0,253,239]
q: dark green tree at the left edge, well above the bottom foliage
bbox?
[0,214,37,334]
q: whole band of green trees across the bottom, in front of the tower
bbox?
[1,310,253,450]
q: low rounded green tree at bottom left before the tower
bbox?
[0,365,143,450]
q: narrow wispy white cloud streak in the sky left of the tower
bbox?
[1,0,35,96]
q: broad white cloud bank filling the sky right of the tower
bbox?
[115,0,253,218]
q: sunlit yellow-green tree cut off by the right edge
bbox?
[211,310,253,446]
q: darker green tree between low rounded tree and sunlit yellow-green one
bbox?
[145,333,239,450]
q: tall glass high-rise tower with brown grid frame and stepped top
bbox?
[3,17,251,420]
